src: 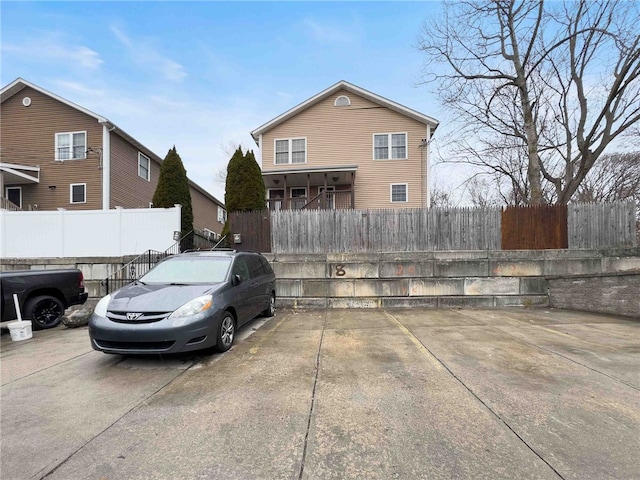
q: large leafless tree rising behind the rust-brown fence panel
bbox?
[418,0,640,204]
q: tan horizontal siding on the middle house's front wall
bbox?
[261,90,427,209]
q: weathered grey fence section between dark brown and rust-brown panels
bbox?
[271,208,500,253]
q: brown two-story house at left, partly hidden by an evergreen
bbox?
[0,78,225,237]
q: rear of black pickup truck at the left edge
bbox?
[0,268,89,330]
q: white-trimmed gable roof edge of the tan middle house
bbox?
[251,80,440,146]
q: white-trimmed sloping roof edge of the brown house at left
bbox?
[0,78,224,207]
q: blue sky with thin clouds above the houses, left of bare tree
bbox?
[0,1,444,200]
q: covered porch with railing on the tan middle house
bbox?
[262,165,357,210]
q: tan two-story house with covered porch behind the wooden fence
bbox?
[251,81,438,209]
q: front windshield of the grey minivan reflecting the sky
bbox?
[140,256,231,284]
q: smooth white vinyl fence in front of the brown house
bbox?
[0,205,181,258]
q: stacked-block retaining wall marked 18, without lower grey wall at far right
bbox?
[268,248,640,308]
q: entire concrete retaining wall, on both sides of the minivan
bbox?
[0,248,640,316]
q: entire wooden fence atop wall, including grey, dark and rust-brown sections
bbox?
[229,202,638,253]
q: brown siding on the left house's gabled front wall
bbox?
[0,87,102,210]
